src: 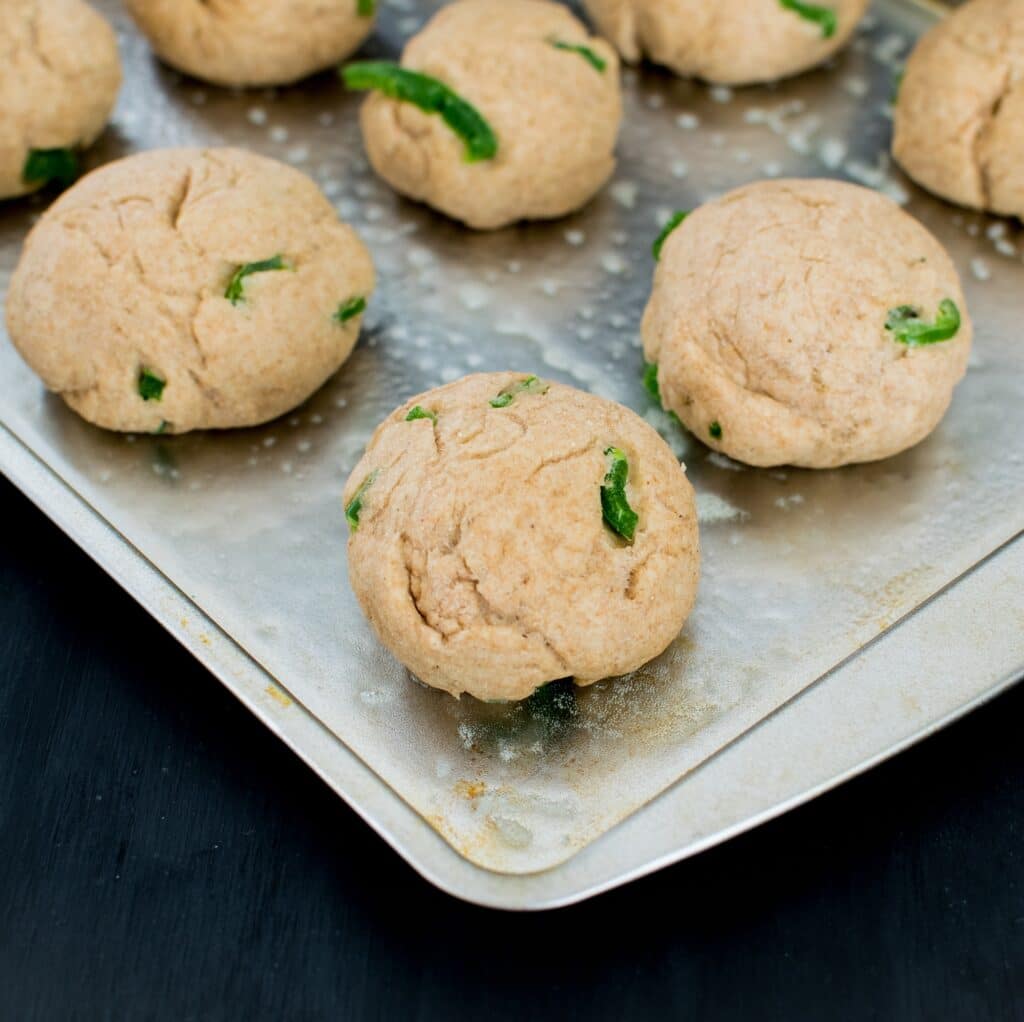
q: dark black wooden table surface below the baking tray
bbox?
[0,481,1024,1022]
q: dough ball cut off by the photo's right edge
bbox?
[893,0,1024,218]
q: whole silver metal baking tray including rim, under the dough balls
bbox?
[0,0,1024,908]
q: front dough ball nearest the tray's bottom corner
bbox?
[344,373,699,700]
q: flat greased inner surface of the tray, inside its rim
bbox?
[0,2,1024,874]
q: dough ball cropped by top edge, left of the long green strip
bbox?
[125,0,374,85]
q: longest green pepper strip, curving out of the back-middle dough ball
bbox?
[341,60,498,163]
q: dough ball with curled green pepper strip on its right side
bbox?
[641,180,972,468]
